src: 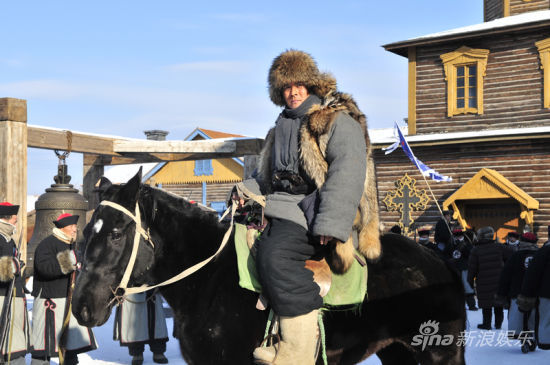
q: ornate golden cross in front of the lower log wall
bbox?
[383,173,430,235]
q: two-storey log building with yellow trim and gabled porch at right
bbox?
[378,0,550,241]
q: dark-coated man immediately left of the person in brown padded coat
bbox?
[449,228,477,311]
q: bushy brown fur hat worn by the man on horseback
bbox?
[267,49,336,107]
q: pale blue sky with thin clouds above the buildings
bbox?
[0,0,483,194]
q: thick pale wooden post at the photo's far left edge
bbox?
[0,98,27,261]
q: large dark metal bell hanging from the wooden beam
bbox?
[25,155,88,277]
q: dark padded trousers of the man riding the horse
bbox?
[255,219,323,317]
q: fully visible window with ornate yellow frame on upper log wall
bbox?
[440,47,489,117]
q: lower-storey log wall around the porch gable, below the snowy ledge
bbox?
[374,139,550,243]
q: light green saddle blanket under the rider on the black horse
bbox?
[234,223,367,307]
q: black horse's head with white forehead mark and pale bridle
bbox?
[72,169,154,327]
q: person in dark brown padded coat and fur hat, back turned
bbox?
[468,227,512,330]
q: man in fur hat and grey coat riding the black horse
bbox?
[233,50,381,364]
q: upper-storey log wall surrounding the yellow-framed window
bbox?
[416,30,550,134]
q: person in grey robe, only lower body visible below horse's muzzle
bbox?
[114,289,168,365]
